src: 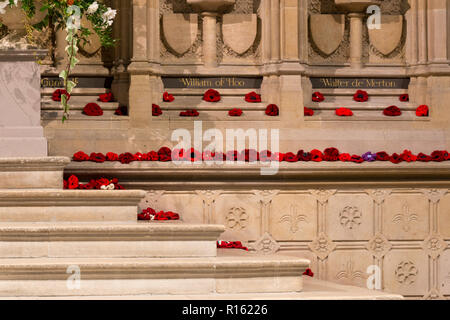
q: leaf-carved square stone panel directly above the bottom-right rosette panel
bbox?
[383,194,429,240]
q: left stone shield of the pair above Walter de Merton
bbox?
[309,14,345,55]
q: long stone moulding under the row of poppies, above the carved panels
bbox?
[66,162,450,190]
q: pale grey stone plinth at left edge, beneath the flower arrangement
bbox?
[0,49,47,157]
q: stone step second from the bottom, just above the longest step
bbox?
[0,221,225,259]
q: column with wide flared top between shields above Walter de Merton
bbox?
[334,0,380,69]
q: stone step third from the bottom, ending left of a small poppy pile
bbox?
[0,189,146,222]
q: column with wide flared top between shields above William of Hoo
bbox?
[186,0,236,68]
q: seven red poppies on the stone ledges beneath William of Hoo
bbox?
[158,89,280,117]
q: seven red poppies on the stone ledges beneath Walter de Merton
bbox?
[304,90,429,117]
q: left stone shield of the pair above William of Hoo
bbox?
[162,13,198,55]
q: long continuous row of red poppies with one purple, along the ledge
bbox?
[73,147,450,164]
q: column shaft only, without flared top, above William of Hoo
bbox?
[202,12,217,68]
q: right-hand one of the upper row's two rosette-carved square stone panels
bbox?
[326,194,373,240]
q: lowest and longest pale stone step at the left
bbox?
[0,254,310,297]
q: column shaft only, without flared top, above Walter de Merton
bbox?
[348,13,365,69]
